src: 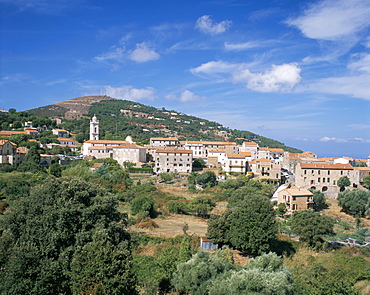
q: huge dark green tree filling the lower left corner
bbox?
[0,177,136,294]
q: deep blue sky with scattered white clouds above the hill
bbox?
[0,0,370,158]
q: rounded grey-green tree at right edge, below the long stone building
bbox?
[338,188,370,216]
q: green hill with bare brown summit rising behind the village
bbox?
[27,95,302,153]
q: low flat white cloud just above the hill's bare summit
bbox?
[104,85,156,101]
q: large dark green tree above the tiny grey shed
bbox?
[207,195,277,255]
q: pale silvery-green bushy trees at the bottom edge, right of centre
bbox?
[172,249,293,295]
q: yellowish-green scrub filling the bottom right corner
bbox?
[285,248,370,295]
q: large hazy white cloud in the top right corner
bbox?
[287,0,370,41]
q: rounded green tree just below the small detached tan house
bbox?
[289,210,335,248]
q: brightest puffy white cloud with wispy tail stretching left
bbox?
[190,61,302,92]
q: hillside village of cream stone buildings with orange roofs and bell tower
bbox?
[0,113,370,212]
